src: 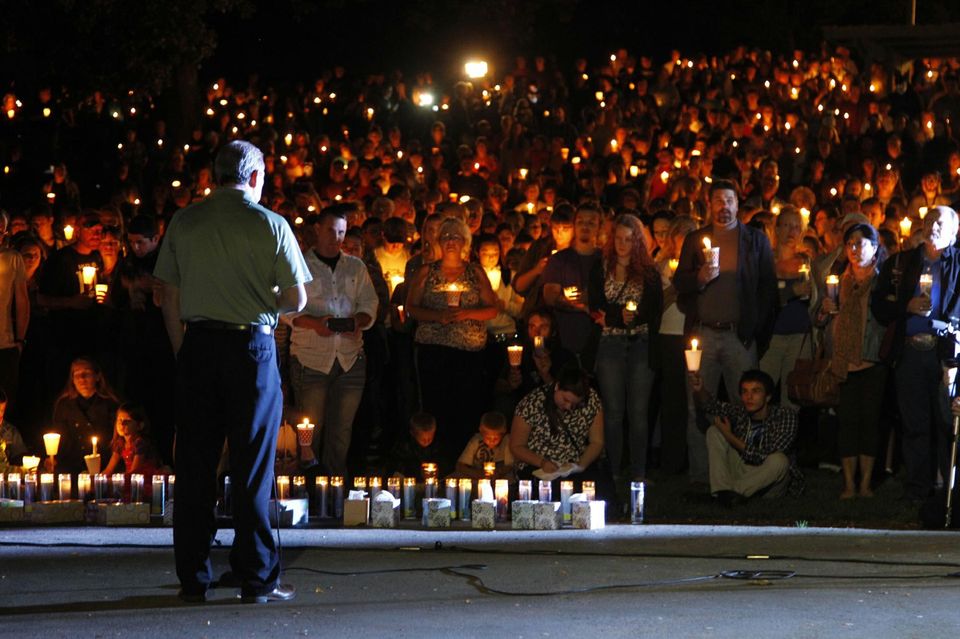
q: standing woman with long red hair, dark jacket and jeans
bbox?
[596,214,663,481]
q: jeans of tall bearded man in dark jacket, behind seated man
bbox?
[687,326,757,482]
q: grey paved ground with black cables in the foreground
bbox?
[0,525,960,639]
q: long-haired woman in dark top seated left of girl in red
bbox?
[48,357,120,472]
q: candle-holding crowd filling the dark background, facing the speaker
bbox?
[0,42,960,516]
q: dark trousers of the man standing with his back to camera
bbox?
[173,325,283,595]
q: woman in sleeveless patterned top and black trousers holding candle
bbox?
[406,218,497,457]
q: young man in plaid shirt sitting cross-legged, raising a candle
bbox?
[690,370,804,506]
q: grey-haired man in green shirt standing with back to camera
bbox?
[154,141,310,603]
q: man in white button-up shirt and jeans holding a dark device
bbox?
[284,205,378,475]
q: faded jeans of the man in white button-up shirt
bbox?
[290,353,367,477]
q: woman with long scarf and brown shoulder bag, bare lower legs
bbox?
[817,224,887,499]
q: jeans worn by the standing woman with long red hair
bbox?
[596,335,654,478]
